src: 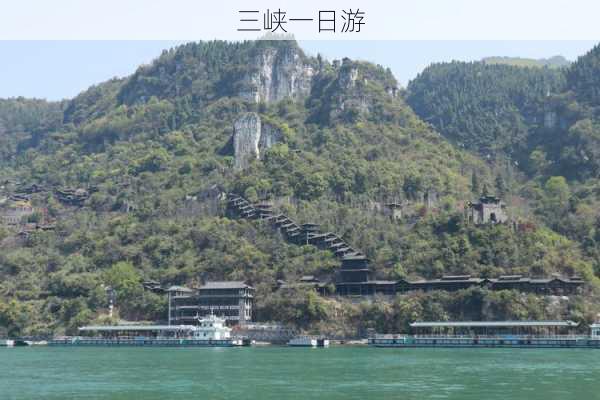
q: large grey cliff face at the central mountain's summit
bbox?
[239,48,314,103]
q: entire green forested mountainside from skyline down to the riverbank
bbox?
[0,41,600,335]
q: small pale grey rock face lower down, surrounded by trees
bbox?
[233,113,282,169]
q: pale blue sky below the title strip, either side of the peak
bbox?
[0,40,596,100]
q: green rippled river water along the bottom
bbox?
[0,347,600,400]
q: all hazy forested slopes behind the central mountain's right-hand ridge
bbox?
[407,46,600,310]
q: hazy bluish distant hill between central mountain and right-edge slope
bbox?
[407,62,565,159]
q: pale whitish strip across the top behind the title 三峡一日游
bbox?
[0,0,600,40]
